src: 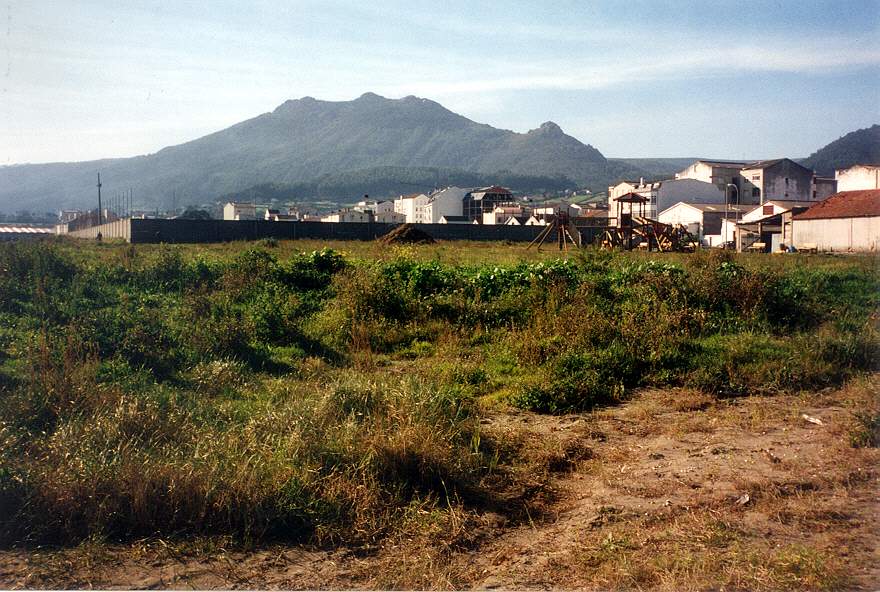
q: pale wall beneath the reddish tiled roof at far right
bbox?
[792,216,880,253]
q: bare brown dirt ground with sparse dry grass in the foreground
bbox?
[0,376,880,590]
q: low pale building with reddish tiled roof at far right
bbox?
[792,189,880,253]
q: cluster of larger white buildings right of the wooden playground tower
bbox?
[608,158,880,251]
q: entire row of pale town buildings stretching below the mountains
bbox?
[210,158,880,251]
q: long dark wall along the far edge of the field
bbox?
[71,218,604,244]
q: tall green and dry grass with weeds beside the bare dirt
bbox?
[0,242,880,543]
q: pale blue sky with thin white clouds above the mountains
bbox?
[0,0,880,165]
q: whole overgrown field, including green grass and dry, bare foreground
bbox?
[0,241,880,589]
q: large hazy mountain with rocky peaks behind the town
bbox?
[0,93,612,211]
